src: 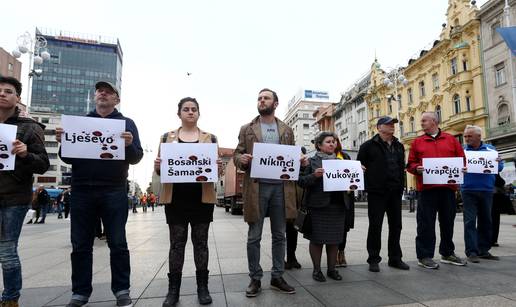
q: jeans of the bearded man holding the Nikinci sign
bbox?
[247,183,286,280]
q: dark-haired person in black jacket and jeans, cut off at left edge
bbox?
[0,77,49,307]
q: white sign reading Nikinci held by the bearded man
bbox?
[251,143,301,180]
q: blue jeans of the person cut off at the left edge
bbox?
[0,204,29,301]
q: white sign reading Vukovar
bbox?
[322,160,364,192]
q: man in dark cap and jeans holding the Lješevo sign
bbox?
[56,81,143,307]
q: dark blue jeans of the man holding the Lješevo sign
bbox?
[70,186,131,301]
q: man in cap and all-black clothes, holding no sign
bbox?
[357,116,410,272]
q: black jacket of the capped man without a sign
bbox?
[357,134,405,193]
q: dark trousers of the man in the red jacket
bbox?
[416,188,457,259]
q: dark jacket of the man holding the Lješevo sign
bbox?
[59,109,143,186]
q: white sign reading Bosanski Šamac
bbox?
[160,143,219,183]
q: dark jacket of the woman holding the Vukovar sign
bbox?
[297,155,353,210]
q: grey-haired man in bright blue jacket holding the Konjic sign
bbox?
[460,125,503,263]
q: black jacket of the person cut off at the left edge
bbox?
[0,108,50,206]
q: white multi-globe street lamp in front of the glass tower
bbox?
[12,32,50,113]
